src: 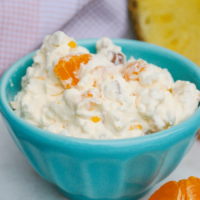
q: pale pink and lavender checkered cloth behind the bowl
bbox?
[0,0,136,77]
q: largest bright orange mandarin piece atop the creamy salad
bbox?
[54,54,91,89]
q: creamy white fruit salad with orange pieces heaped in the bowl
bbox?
[10,31,200,139]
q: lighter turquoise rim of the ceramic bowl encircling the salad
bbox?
[0,39,200,145]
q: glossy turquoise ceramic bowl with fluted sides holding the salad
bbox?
[0,39,200,200]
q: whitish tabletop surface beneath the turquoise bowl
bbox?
[0,113,200,200]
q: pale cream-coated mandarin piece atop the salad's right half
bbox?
[124,60,147,81]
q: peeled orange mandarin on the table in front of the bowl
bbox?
[149,176,200,200]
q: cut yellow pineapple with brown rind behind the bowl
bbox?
[128,0,200,67]
